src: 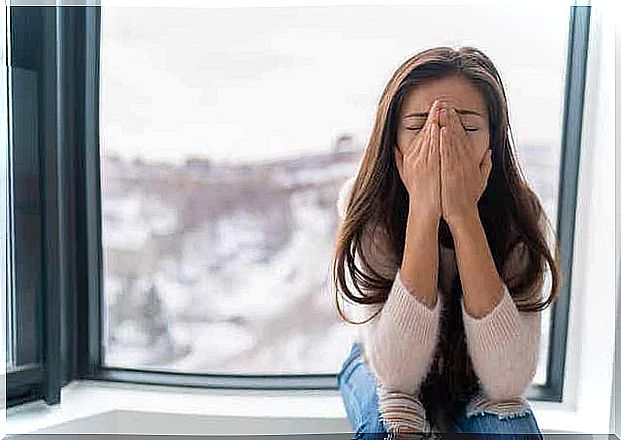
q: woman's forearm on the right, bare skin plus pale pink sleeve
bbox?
[449,212,541,399]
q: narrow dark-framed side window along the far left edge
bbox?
[2,6,52,403]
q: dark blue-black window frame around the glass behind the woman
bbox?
[7,5,590,407]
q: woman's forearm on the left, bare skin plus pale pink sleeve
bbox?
[369,210,442,394]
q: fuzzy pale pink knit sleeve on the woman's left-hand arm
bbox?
[337,179,442,395]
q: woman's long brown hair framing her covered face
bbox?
[332,47,561,430]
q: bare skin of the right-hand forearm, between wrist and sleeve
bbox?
[449,209,503,318]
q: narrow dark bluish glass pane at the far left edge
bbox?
[7,67,42,368]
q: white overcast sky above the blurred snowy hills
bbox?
[100,3,569,162]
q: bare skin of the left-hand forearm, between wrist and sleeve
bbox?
[400,204,440,308]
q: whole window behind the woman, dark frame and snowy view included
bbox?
[7,1,589,408]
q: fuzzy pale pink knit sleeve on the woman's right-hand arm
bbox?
[461,242,542,400]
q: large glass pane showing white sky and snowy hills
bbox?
[101,5,569,383]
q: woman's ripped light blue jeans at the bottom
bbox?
[337,342,543,440]
